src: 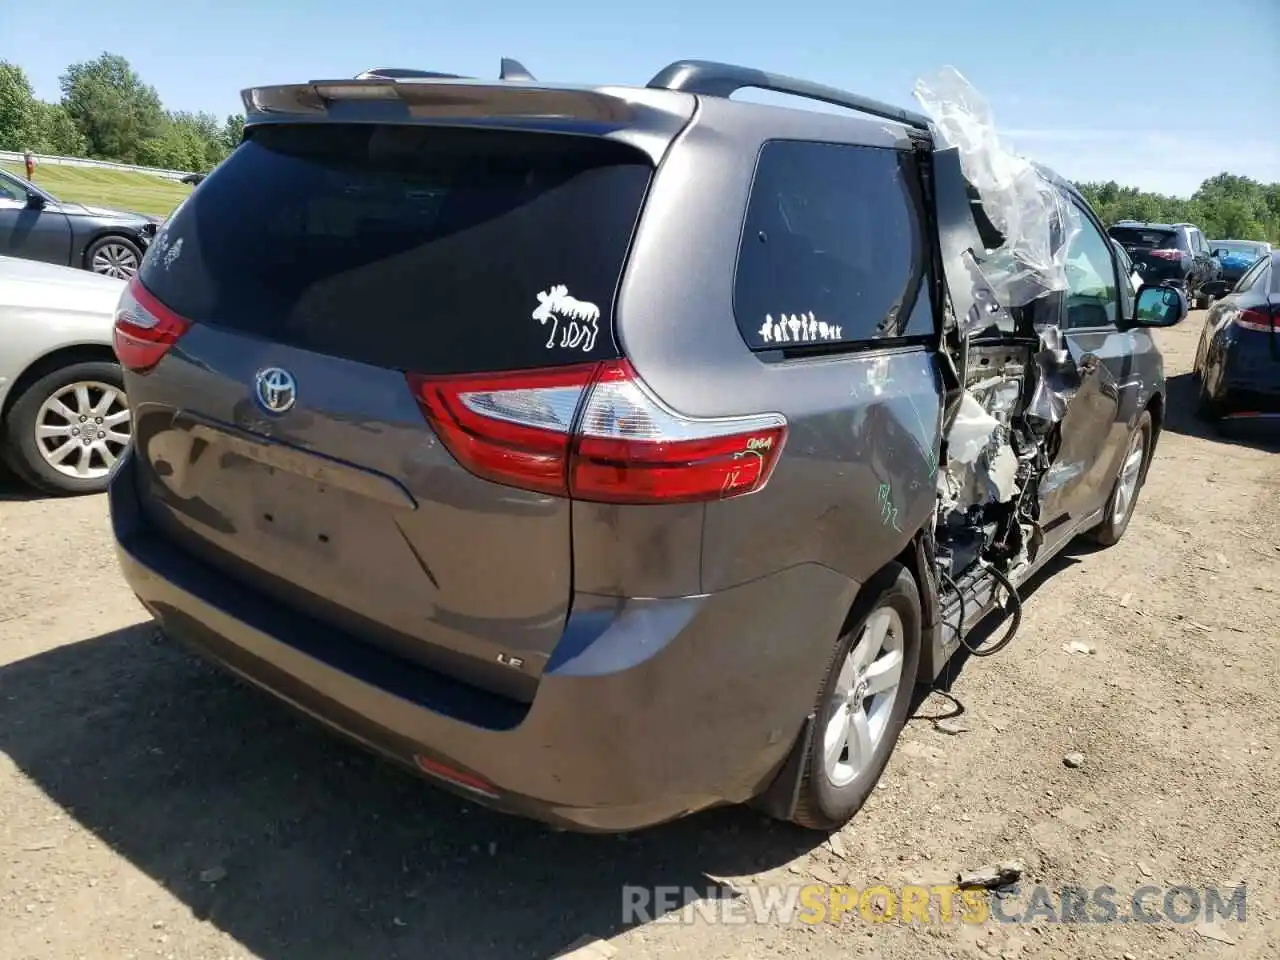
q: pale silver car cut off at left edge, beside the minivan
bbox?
[0,257,129,494]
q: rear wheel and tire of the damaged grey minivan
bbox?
[791,563,922,832]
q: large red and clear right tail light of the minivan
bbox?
[408,360,787,503]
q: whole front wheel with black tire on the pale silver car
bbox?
[3,360,131,495]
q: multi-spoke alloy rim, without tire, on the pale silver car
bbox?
[36,380,129,480]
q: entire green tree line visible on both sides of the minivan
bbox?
[0,54,1280,244]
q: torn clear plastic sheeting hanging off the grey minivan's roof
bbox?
[914,67,1080,308]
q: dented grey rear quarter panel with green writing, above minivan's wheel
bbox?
[703,348,942,591]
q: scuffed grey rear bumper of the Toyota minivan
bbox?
[109,460,856,831]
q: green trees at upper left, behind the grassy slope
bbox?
[0,54,244,173]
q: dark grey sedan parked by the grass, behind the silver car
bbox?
[0,170,160,279]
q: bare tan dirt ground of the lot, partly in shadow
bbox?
[0,314,1280,960]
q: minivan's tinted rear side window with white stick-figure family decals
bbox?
[733,140,933,349]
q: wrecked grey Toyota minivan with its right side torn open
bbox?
[110,61,1185,831]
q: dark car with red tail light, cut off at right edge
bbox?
[1196,253,1280,420]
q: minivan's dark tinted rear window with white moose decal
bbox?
[141,124,652,374]
